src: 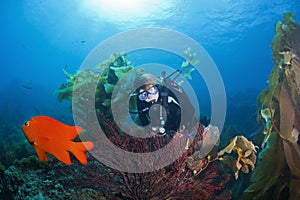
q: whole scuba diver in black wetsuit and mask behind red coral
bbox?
[130,70,198,136]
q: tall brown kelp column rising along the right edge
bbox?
[242,13,300,199]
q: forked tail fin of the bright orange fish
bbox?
[70,142,94,165]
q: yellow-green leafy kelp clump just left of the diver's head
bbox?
[56,53,136,117]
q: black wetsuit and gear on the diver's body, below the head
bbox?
[137,83,197,134]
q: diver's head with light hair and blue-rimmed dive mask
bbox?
[134,73,159,102]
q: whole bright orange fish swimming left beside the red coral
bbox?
[22,116,94,165]
